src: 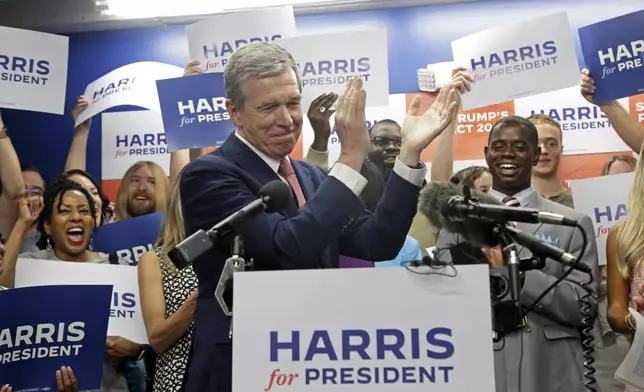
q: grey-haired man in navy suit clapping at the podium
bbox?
[180,42,457,392]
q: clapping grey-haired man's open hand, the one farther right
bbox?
[399,83,458,167]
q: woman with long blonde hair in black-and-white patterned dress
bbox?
[138,175,197,392]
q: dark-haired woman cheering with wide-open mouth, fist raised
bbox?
[0,177,142,392]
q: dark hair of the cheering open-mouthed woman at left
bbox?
[37,175,96,249]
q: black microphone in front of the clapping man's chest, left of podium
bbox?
[168,180,292,270]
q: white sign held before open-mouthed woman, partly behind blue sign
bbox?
[16,259,148,344]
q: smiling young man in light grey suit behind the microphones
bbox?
[437,116,599,392]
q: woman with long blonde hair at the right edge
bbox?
[606,152,644,392]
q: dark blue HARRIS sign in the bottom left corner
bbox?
[0,286,112,391]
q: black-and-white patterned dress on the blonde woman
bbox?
[153,248,197,392]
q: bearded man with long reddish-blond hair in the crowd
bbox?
[115,161,170,221]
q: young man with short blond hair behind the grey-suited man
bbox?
[528,114,574,208]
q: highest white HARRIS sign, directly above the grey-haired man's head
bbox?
[186,6,295,73]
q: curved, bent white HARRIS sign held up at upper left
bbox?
[75,61,183,125]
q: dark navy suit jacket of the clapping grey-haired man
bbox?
[180,134,420,392]
